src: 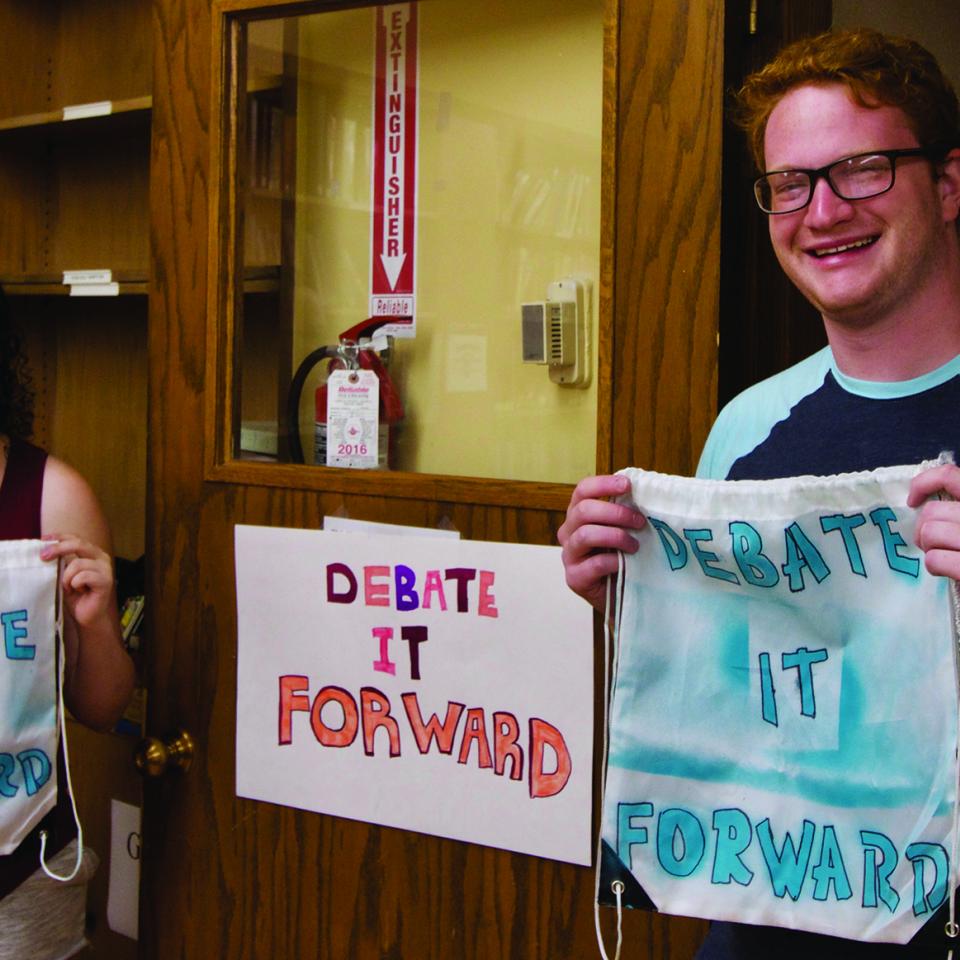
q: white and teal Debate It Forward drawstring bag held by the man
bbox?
[597,466,958,956]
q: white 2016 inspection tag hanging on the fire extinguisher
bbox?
[327,370,380,469]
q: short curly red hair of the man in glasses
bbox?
[734,28,960,171]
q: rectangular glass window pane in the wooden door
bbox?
[235,0,603,482]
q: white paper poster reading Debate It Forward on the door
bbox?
[235,526,593,864]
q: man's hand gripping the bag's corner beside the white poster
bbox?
[557,476,646,610]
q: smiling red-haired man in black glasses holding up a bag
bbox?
[558,30,960,960]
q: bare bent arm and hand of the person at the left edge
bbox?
[40,457,134,730]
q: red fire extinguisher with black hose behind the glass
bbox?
[287,316,404,470]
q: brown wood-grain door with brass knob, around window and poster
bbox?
[140,0,722,960]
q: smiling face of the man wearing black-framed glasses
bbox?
[764,84,956,326]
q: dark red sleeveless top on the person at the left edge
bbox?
[0,440,77,897]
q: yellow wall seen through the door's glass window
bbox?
[294,0,603,482]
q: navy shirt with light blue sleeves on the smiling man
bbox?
[697,347,960,960]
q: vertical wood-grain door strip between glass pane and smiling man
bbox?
[613,0,723,473]
